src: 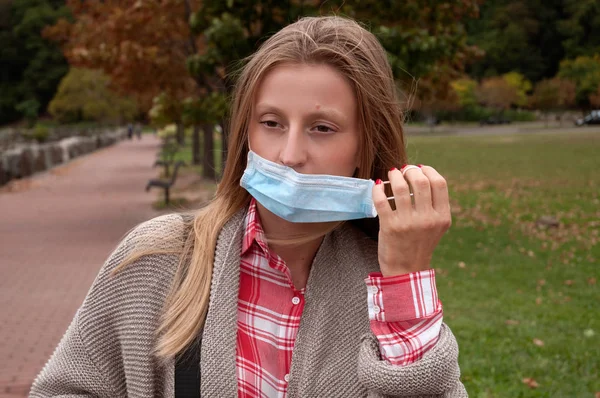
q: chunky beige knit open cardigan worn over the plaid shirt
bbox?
[30,211,467,398]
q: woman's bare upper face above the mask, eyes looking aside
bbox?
[248,64,360,177]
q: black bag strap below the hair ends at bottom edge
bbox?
[175,342,200,398]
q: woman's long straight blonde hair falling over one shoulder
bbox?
[120,16,406,358]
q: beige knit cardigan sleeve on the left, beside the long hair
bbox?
[30,215,183,398]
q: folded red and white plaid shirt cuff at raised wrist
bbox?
[365,269,439,322]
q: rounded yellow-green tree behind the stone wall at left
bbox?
[48,68,138,123]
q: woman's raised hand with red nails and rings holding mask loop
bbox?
[373,165,452,276]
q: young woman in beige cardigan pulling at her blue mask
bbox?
[31,17,466,397]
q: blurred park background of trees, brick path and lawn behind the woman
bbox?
[0,0,600,398]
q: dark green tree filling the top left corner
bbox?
[0,0,69,124]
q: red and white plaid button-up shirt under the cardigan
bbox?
[236,199,442,398]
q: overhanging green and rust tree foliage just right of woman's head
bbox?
[340,0,483,110]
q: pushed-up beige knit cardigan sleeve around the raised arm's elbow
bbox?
[358,324,468,398]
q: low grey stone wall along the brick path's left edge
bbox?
[0,129,127,186]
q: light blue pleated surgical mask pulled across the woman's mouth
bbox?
[240,151,377,222]
